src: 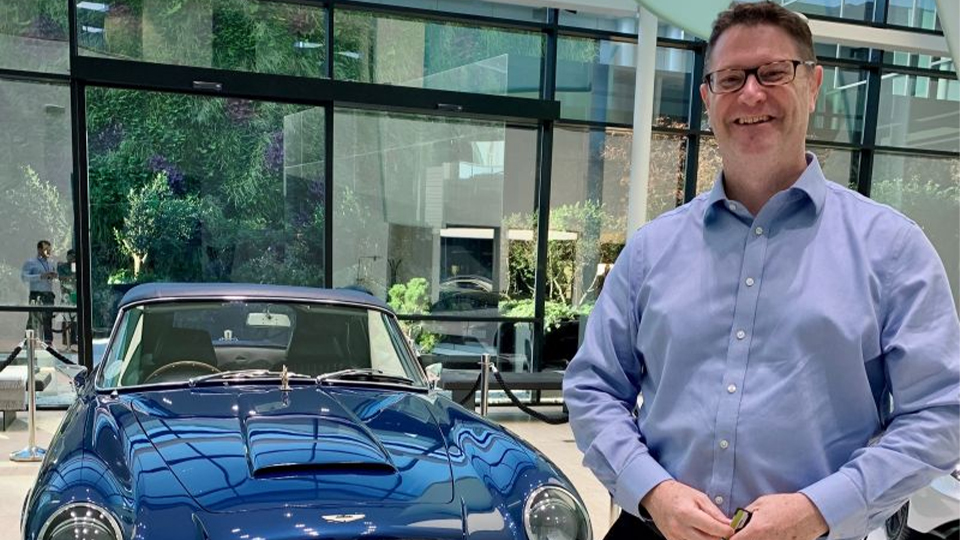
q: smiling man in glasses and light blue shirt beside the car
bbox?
[564,2,960,540]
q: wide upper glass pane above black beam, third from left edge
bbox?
[334,11,544,98]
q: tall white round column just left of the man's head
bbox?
[627,6,657,234]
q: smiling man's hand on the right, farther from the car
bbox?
[730,493,830,540]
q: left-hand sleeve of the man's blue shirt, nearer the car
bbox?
[563,235,671,515]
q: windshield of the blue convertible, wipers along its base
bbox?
[99,300,424,388]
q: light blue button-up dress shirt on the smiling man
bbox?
[564,154,960,539]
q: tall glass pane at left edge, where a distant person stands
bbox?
[0,79,76,310]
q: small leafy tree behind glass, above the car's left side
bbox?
[114,173,200,279]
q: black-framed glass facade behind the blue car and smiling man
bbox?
[0,0,960,390]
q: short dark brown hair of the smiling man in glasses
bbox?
[705,0,817,66]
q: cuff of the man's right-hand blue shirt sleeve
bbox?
[800,472,867,540]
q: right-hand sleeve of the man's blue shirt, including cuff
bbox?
[802,224,960,539]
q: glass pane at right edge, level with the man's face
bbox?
[877,72,960,152]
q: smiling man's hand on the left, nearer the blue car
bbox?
[640,480,733,540]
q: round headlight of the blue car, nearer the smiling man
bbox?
[523,486,593,540]
